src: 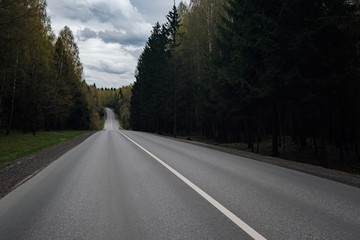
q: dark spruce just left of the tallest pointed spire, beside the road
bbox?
[131,23,171,133]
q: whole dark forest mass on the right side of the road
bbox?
[130,0,360,169]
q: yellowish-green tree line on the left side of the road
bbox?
[0,0,102,134]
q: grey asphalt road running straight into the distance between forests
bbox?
[0,110,360,239]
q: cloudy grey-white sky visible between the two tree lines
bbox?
[47,0,189,88]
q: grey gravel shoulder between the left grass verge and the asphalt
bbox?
[0,132,95,199]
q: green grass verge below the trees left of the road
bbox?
[0,131,89,164]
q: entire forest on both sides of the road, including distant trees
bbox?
[0,0,360,169]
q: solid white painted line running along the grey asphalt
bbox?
[120,131,266,240]
